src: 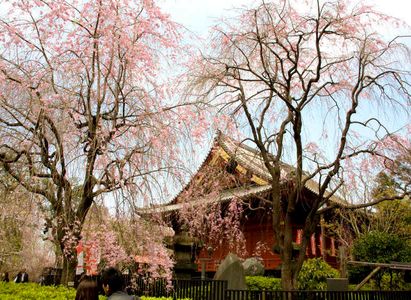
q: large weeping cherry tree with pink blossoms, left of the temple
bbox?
[0,0,192,282]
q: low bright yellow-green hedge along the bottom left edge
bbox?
[0,282,189,300]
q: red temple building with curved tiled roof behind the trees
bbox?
[151,133,341,278]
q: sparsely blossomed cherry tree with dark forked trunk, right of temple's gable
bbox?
[191,0,411,290]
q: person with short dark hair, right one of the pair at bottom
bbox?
[101,267,139,300]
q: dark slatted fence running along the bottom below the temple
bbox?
[136,280,411,300]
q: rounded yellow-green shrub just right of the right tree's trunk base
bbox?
[298,258,339,290]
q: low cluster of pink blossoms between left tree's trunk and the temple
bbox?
[81,205,174,284]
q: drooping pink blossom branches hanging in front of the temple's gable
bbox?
[177,163,247,257]
